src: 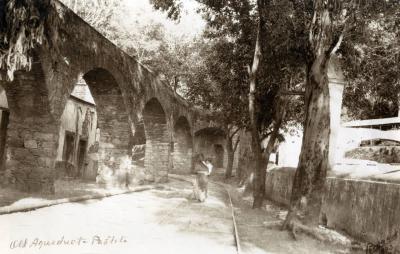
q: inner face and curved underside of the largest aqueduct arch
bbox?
[83,69,133,187]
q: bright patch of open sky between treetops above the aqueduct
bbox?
[122,0,205,38]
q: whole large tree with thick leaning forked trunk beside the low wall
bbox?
[285,0,398,228]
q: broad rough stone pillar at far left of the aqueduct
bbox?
[6,115,58,193]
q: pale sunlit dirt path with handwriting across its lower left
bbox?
[0,180,236,254]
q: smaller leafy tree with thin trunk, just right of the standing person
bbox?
[186,39,247,179]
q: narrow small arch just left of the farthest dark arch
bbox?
[172,117,193,174]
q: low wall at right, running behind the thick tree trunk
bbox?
[266,168,400,251]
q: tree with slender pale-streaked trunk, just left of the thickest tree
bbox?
[199,1,299,208]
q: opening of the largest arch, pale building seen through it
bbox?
[55,77,98,180]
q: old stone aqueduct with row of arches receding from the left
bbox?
[0,0,225,192]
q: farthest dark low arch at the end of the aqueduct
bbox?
[194,127,228,170]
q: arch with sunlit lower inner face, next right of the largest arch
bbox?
[143,98,170,182]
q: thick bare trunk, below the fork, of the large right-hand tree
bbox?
[285,54,330,227]
